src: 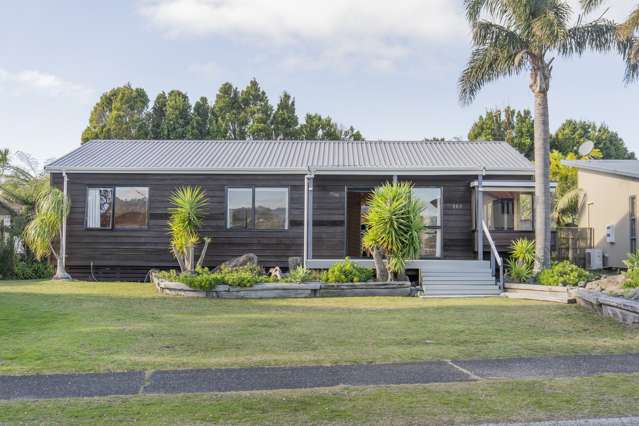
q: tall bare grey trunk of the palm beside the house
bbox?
[535,90,551,272]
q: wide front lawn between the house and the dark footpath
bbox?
[0,281,639,374]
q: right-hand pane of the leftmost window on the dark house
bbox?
[114,186,149,229]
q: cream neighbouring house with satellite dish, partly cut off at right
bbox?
[562,160,639,268]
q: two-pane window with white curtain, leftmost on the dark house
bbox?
[86,186,149,229]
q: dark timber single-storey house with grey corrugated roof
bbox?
[46,140,534,292]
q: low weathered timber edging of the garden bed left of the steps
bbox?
[153,277,411,299]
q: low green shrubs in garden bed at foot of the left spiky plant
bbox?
[157,266,272,291]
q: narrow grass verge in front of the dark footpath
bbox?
[0,374,639,425]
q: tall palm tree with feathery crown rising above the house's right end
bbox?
[459,0,616,271]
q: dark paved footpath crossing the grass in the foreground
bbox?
[0,354,639,400]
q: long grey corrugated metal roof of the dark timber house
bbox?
[46,140,532,174]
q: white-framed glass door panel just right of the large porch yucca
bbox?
[413,188,442,257]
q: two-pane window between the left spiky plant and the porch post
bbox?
[226,187,288,230]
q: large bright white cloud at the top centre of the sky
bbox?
[139,0,468,71]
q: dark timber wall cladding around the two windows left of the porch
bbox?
[51,173,304,279]
